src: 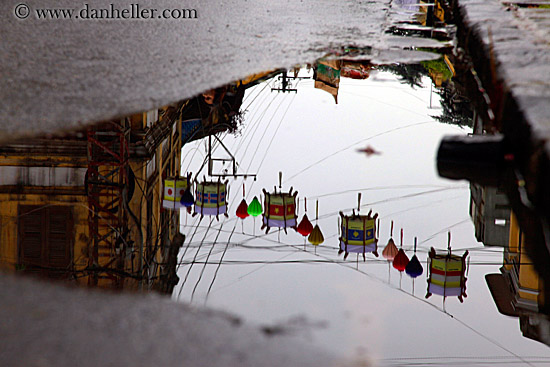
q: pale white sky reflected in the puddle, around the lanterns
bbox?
[173,69,550,366]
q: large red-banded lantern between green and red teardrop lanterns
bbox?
[261,172,298,234]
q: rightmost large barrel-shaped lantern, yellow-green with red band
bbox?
[426,233,468,302]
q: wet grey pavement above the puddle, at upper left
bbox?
[0,0,387,141]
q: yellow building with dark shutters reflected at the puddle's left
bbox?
[0,108,182,290]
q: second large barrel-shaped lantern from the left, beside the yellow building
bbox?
[193,181,228,219]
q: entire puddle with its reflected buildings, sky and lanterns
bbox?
[0,2,550,366]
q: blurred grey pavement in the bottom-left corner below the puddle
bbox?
[0,275,346,367]
